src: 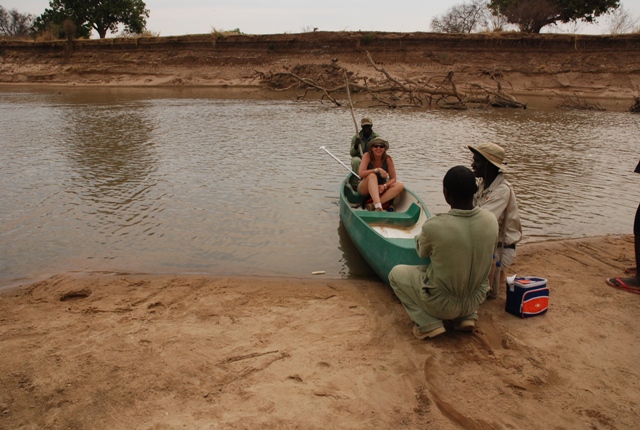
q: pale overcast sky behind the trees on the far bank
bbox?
[0,0,640,37]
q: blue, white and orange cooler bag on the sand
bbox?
[504,276,549,318]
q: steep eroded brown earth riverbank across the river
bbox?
[0,32,640,111]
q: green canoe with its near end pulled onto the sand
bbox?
[340,175,431,285]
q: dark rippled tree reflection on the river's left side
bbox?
[59,106,158,220]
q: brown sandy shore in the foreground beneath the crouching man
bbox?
[0,236,640,429]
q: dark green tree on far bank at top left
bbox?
[34,0,149,39]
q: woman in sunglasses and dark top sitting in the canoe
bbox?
[358,137,404,211]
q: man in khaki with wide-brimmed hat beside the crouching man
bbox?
[467,143,522,297]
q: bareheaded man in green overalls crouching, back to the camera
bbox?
[389,166,498,339]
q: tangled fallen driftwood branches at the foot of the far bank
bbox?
[256,51,526,109]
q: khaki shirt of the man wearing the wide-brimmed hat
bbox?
[473,173,522,246]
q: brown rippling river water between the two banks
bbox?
[0,87,640,286]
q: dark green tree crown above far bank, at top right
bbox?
[489,0,620,33]
